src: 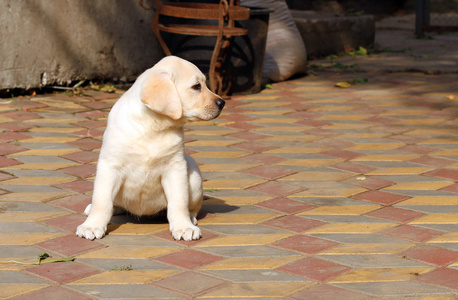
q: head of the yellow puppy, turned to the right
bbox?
[141,56,225,121]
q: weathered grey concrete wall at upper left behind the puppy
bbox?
[0,0,162,90]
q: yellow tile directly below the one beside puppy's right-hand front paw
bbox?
[200,255,301,270]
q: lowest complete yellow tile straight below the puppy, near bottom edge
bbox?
[70,266,180,285]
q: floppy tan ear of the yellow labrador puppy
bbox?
[141,72,183,120]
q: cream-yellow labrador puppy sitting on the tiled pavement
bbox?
[76,56,225,241]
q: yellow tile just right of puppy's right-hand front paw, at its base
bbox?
[196,234,291,247]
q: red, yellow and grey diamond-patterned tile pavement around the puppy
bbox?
[0,69,458,299]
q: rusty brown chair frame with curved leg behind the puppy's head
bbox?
[153,0,250,96]
